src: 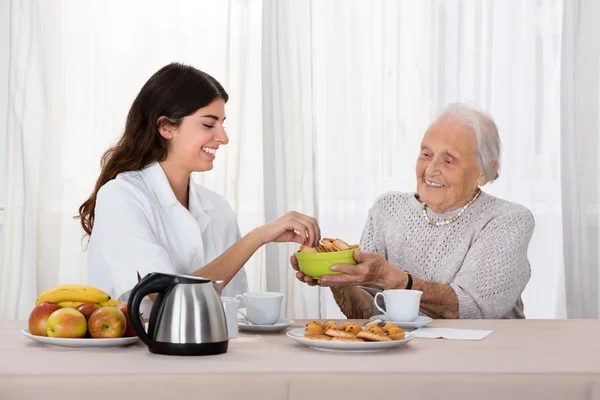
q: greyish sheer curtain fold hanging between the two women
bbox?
[262,0,324,318]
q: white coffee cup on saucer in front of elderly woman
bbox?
[375,289,423,322]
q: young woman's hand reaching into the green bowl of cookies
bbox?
[255,211,321,247]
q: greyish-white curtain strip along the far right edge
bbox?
[561,0,600,318]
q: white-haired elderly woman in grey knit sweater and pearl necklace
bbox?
[291,104,535,319]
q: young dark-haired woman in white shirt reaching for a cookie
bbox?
[79,63,321,315]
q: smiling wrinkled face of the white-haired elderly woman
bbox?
[416,119,483,213]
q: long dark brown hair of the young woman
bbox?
[76,63,229,235]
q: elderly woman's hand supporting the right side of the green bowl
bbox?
[316,251,406,289]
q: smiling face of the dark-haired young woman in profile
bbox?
[159,98,229,172]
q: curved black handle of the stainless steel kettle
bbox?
[127,272,177,346]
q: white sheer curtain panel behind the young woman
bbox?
[0,0,265,319]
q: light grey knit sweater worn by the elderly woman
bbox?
[360,192,535,319]
